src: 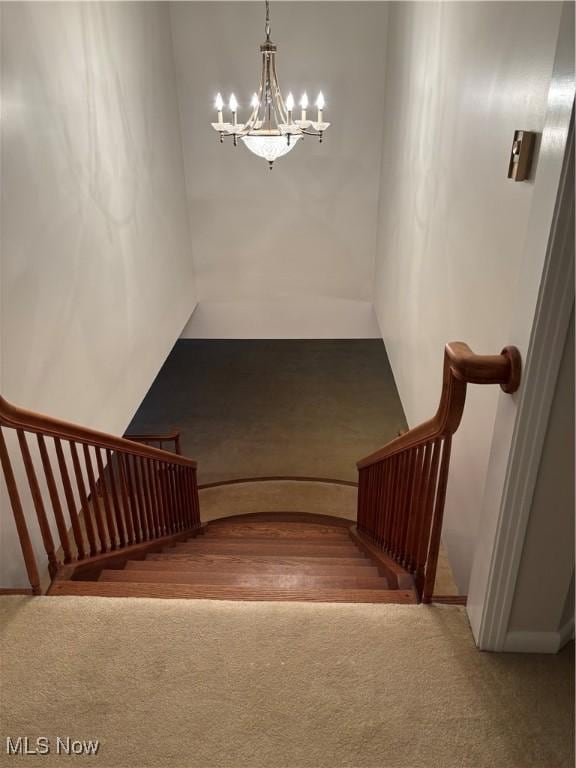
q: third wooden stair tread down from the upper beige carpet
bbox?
[124,558,379,576]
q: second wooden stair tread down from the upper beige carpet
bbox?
[99,570,388,589]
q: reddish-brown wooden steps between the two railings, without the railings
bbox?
[49,513,417,603]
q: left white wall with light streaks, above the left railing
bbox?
[0,2,195,586]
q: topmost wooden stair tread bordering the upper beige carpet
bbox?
[49,580,416,604]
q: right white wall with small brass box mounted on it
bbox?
[374,2,561,591]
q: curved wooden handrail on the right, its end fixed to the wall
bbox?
[357,341,521,469]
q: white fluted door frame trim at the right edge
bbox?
[468,3,574,652]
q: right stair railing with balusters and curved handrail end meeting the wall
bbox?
[357,342,521,603]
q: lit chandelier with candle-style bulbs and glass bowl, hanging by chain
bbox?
[212,0,330,170]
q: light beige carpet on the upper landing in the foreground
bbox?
[0,597,573,768]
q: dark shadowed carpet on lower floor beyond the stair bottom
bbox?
[128,339,406,483]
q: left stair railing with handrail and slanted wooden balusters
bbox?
[0,397,200,594]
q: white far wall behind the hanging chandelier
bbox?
[171,2,387,338]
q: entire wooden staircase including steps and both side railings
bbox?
[0,342,521,603]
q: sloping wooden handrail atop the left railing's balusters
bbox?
[0,396,196,468]
